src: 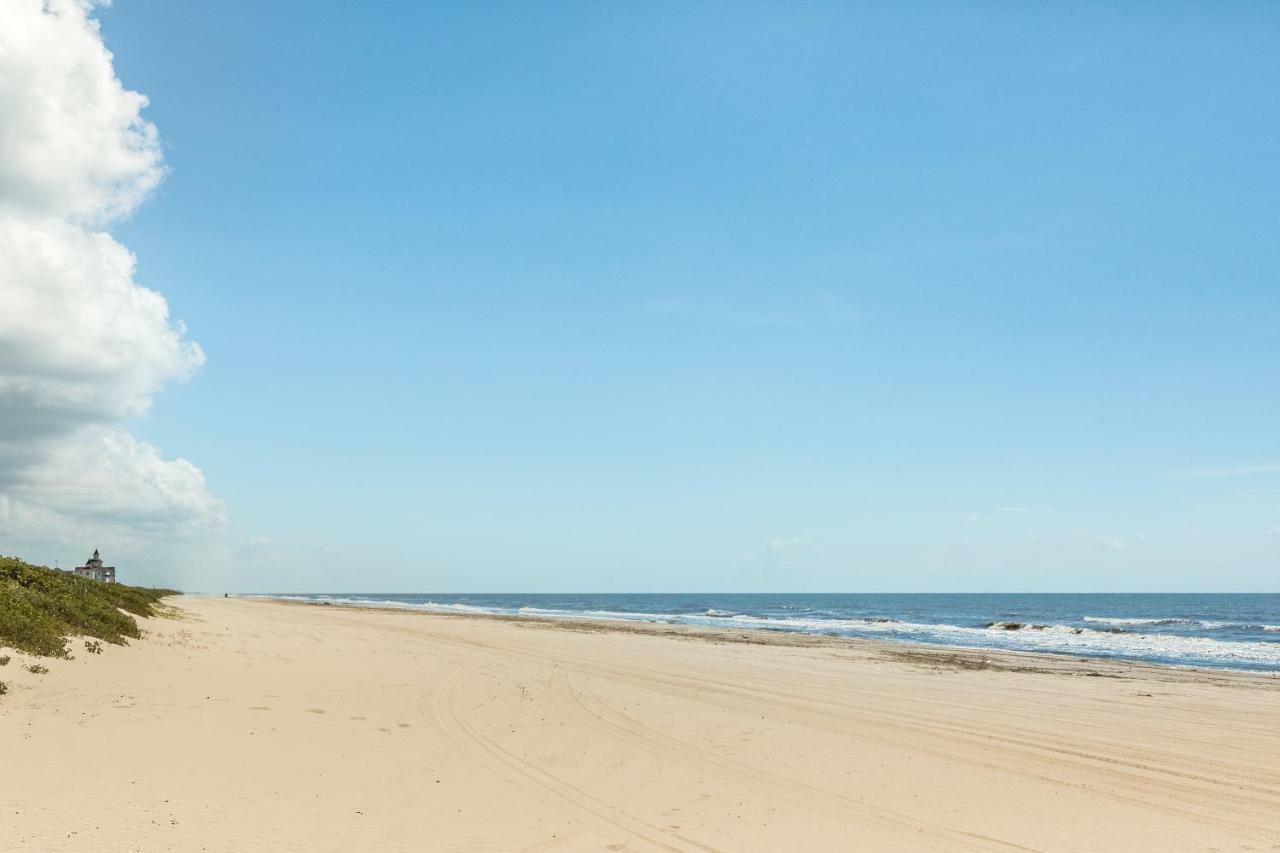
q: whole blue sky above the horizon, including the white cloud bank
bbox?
[0,0,1280,592]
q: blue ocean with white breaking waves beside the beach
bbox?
[259,593,1280,672]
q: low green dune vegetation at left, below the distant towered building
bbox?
[0,557,177,657]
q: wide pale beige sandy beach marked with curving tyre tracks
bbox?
[0,597,1280,853]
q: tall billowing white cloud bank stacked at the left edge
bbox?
[0,0,223,555]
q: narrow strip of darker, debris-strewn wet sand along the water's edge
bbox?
[247,594,1280,686]
